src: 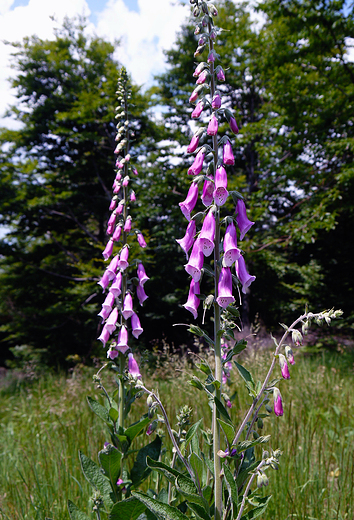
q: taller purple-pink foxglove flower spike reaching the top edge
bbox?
[177,0,255,319]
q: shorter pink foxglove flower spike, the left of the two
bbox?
[98,68,149,379]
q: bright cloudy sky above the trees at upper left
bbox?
[0,0,189,128]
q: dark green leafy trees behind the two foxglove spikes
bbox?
[0,0,354,365]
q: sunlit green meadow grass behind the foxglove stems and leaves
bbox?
[0,351,354,520]
